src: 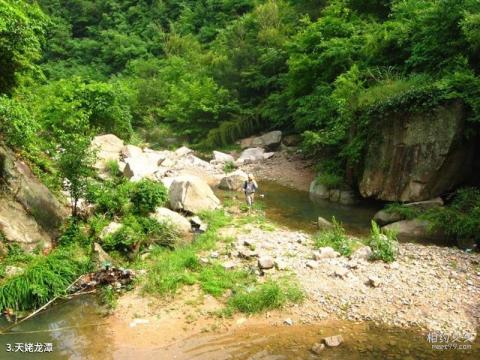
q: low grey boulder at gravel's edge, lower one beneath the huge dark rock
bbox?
[382,219,446,243]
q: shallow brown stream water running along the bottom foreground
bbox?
[0,295,480,360]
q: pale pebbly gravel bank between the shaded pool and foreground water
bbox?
[213,226,480,334]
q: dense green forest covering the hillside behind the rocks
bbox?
[1,0,480,156]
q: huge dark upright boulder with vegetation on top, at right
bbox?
[359,101,475,202]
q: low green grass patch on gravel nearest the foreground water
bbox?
[228,281,305,314]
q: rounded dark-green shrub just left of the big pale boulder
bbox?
[130,179,168,214]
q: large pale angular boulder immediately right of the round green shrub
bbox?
[168,176,220,214]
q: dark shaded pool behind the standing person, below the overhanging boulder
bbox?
[255,181,382,235]
